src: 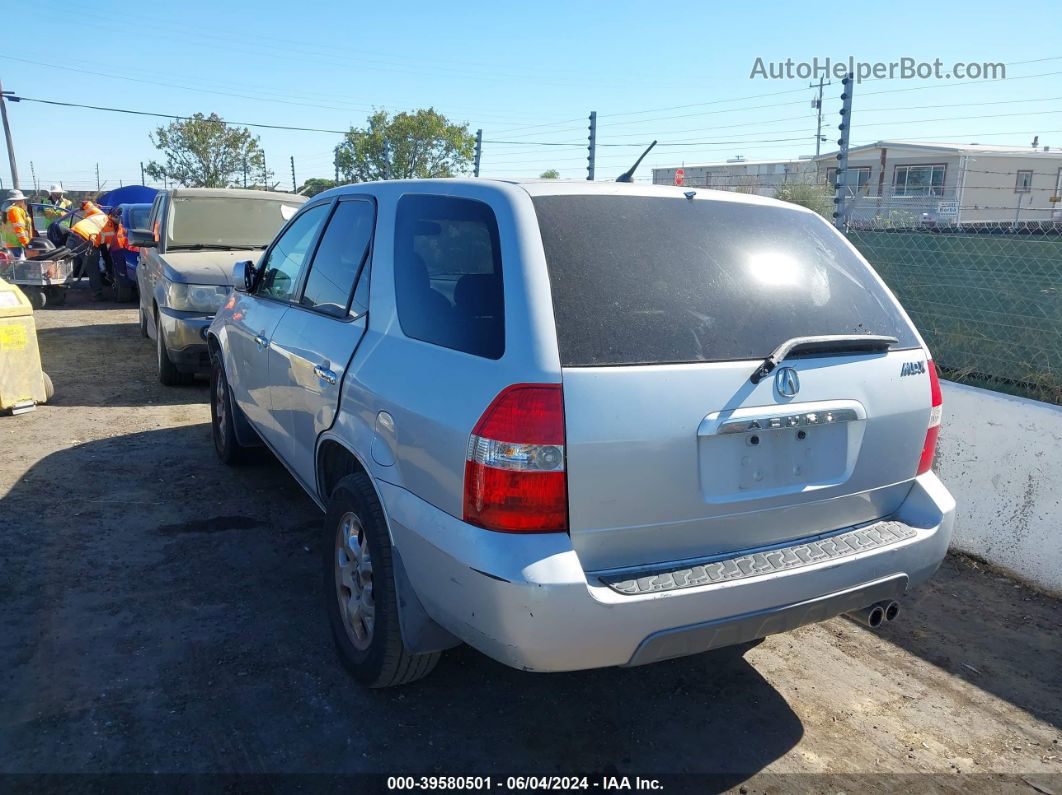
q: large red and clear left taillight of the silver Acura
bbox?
[464,384,568,533]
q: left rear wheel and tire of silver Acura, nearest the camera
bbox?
[323,472,440,688]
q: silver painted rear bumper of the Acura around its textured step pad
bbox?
[379,472,955,671]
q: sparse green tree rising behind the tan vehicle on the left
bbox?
[144,114,266,188]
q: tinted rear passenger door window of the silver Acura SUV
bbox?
[299,201,376,317]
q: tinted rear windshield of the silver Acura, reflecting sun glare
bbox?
[533,195,919,366]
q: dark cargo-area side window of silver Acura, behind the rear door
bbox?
[394,195,506,359]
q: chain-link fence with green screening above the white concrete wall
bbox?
[849,221,1062,404]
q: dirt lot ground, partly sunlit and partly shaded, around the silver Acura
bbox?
[0,292,1062,795]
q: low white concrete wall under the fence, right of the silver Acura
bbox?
[936,381,1062,593]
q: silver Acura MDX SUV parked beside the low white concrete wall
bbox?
[208,179,955,687]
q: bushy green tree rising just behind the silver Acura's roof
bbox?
[336,107,476,183]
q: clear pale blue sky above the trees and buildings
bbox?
[0,0,1062,188]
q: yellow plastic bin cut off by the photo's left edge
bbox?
[0,279,52,414]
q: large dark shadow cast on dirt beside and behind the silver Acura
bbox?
[0,424,803,785]
